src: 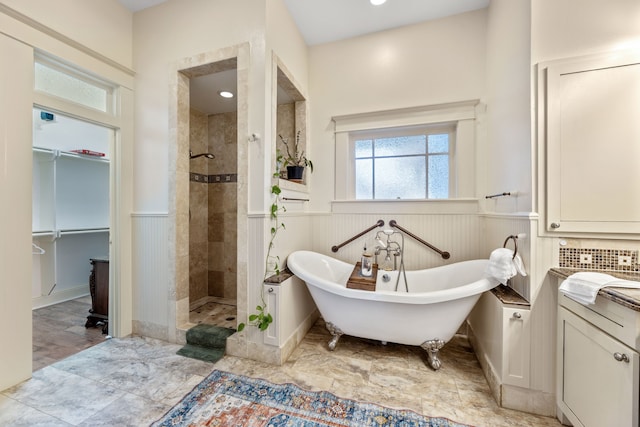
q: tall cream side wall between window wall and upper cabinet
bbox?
[477,0,533,213]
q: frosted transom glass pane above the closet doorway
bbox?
[35,62,111,112]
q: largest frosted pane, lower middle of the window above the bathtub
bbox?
[375,157,427,199]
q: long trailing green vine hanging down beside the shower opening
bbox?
[238,151,287,332]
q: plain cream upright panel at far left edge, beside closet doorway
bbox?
[0,34,33,390]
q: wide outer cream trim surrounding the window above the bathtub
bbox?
[332,99,480,203]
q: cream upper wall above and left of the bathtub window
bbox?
[309,10,487,212]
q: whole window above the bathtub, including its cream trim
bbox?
[332,100,484,202]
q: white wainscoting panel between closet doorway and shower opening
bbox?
[132,213,170,340]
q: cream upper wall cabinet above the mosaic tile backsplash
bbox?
[538,52,640,236]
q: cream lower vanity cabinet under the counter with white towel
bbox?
[557,293,640,427]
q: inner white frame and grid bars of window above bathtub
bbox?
[348,123,456,200]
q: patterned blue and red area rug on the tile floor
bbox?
[152,370,468,427]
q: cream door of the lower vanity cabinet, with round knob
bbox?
[558,308,640,427]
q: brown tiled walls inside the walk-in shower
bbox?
[189,109,238,303]
